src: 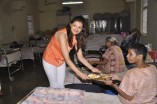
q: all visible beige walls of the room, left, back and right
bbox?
[0,0,157,50]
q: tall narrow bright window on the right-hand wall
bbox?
[141,0,148,34]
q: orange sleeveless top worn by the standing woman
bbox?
[43,28,77,66]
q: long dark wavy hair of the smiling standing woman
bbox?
[66,16,87,52]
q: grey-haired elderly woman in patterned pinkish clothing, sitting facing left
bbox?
[90,36,126,74]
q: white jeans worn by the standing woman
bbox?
[42,59,66,88]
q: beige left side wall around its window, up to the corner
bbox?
[0,0,40,44]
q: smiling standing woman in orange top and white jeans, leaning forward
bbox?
[43,16,100,88]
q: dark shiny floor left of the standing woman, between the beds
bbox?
[0,60,49,104]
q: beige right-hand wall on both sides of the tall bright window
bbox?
[128,0,157,50]
